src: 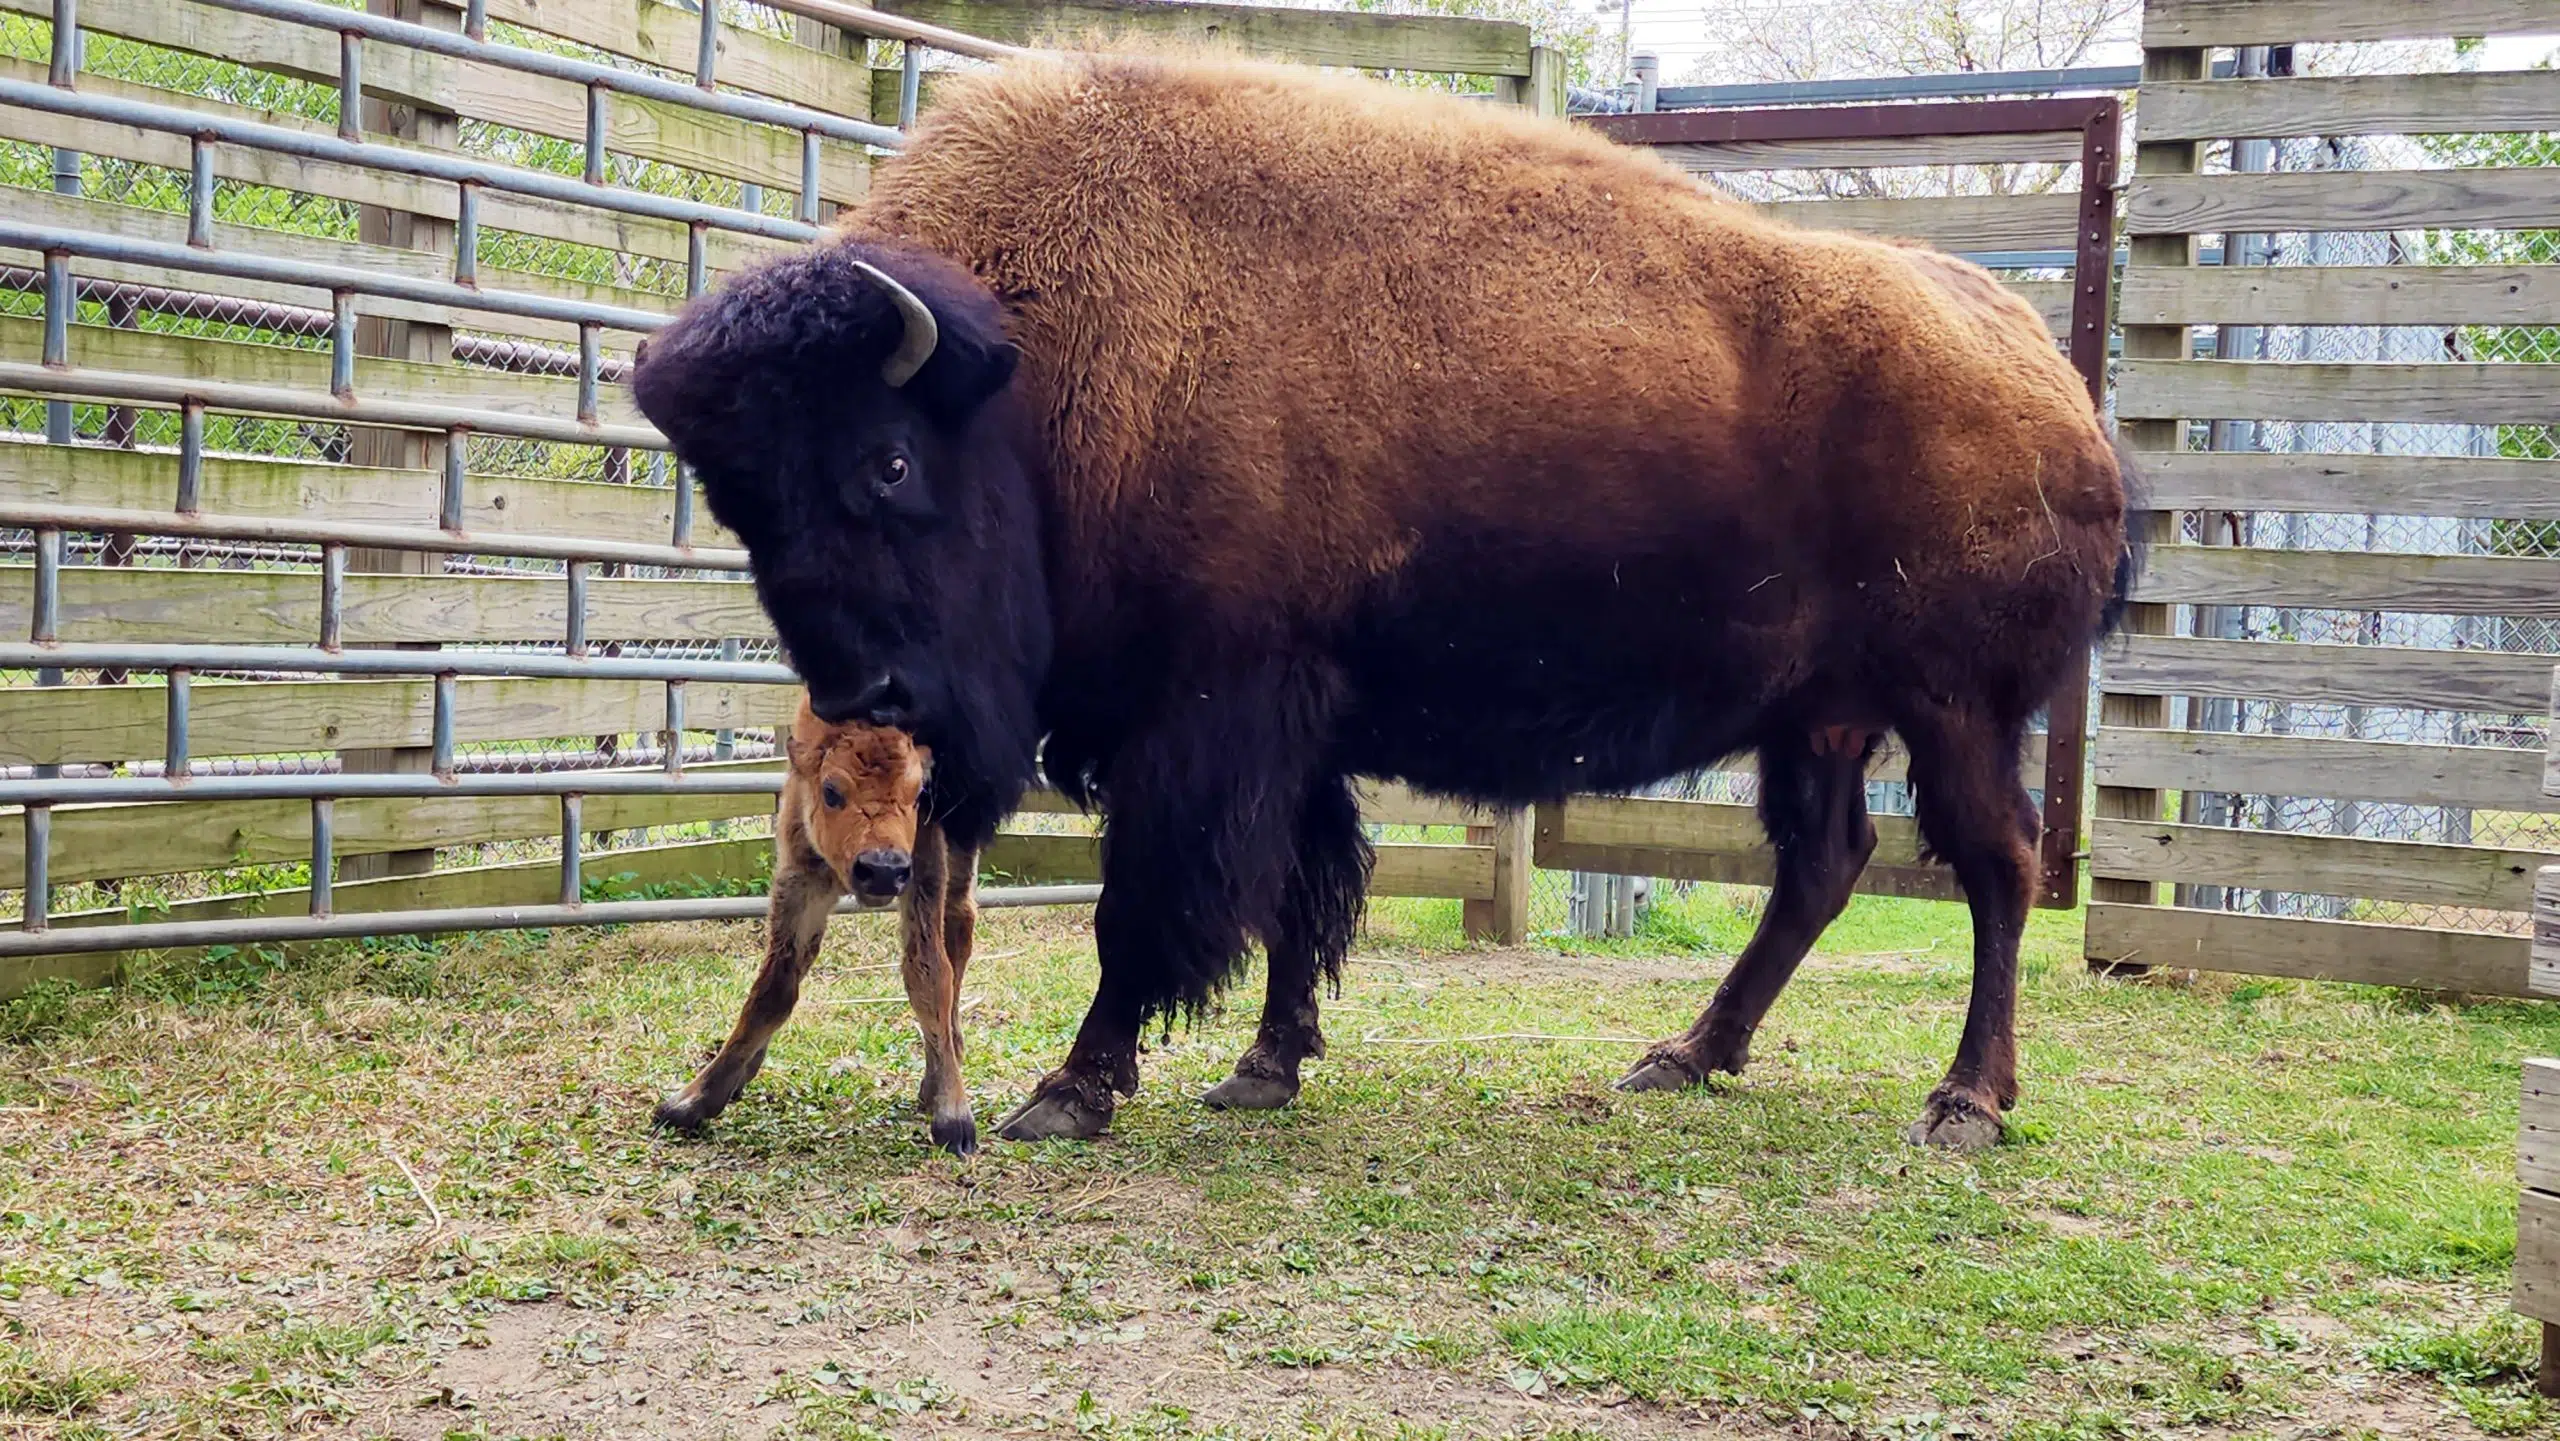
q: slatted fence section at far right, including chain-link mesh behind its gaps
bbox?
[2089,0,2560,993]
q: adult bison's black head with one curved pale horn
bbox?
[632,241,1050,845]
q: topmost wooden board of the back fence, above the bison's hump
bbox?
[881,0,1531,77]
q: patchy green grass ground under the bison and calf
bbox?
[0,886,2560,1441]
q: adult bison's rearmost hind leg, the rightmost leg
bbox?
[1894,706,2038,1149]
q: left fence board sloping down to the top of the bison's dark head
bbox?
[0,56,796,271]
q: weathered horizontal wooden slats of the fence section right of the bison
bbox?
[2086,0,2560,996]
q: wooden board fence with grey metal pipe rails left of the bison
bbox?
[0,0,1562,993]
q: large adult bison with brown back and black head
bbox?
[635,59,2130,1144]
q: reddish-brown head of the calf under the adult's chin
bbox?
[786,699,932,906]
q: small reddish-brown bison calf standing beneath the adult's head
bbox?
[658,699,978,1154]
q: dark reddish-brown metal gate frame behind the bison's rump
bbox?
[1582,95,2125,911]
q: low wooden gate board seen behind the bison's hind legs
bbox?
[1533,796,1964,901]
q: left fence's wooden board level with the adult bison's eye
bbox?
[0,440,740,548]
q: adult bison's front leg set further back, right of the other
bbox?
[1201,776,1372,1111]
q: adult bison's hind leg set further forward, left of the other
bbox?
[1618,724,1882,1090]
